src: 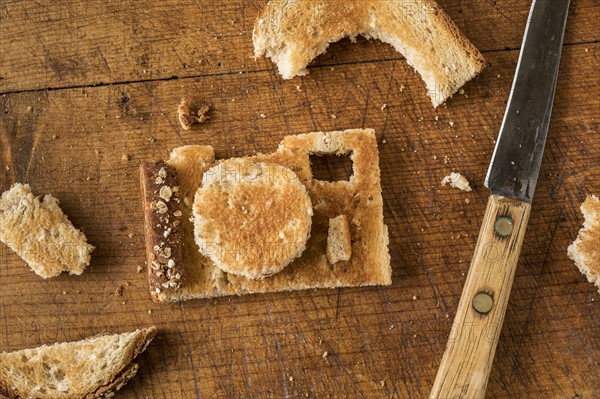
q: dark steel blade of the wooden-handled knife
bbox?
[485,0,569,203]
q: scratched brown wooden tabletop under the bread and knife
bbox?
[0,0,600,398]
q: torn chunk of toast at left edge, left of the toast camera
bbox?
[0,183,94,278]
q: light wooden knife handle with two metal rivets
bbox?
[430,195,531,399]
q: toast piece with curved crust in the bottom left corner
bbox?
[0,326,156,399]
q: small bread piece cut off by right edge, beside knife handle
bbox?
[567,195,600,293]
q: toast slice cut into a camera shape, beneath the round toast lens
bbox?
[140,129,392,302]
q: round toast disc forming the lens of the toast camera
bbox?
[193,158,313,279]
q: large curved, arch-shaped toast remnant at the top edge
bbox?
[252,0,485,107]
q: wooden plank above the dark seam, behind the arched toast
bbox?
[0,0,600,93]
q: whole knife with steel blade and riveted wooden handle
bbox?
[430,0,569,399]
